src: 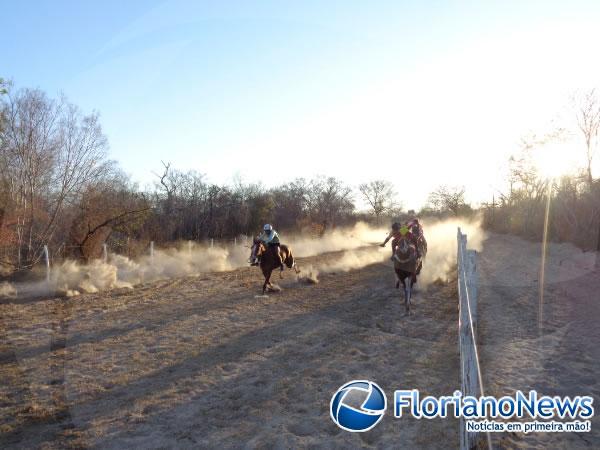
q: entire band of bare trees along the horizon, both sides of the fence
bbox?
[10,79,600,275]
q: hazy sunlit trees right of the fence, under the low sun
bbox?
[482,89,600,251]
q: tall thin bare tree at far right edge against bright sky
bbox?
[573,89,600,189]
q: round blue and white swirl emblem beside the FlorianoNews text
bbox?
[329,380,387,432]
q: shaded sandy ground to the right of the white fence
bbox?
[478,235,600,449]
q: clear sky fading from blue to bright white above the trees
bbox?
[0,1,600,207]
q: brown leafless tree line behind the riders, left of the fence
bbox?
[0,79,466,274]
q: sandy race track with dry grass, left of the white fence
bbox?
[0,250,460,449]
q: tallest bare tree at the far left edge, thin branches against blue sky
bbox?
[0,89,107,267]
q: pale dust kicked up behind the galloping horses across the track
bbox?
[0,219,485,297]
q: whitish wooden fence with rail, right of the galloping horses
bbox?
[457,228,492,450]
